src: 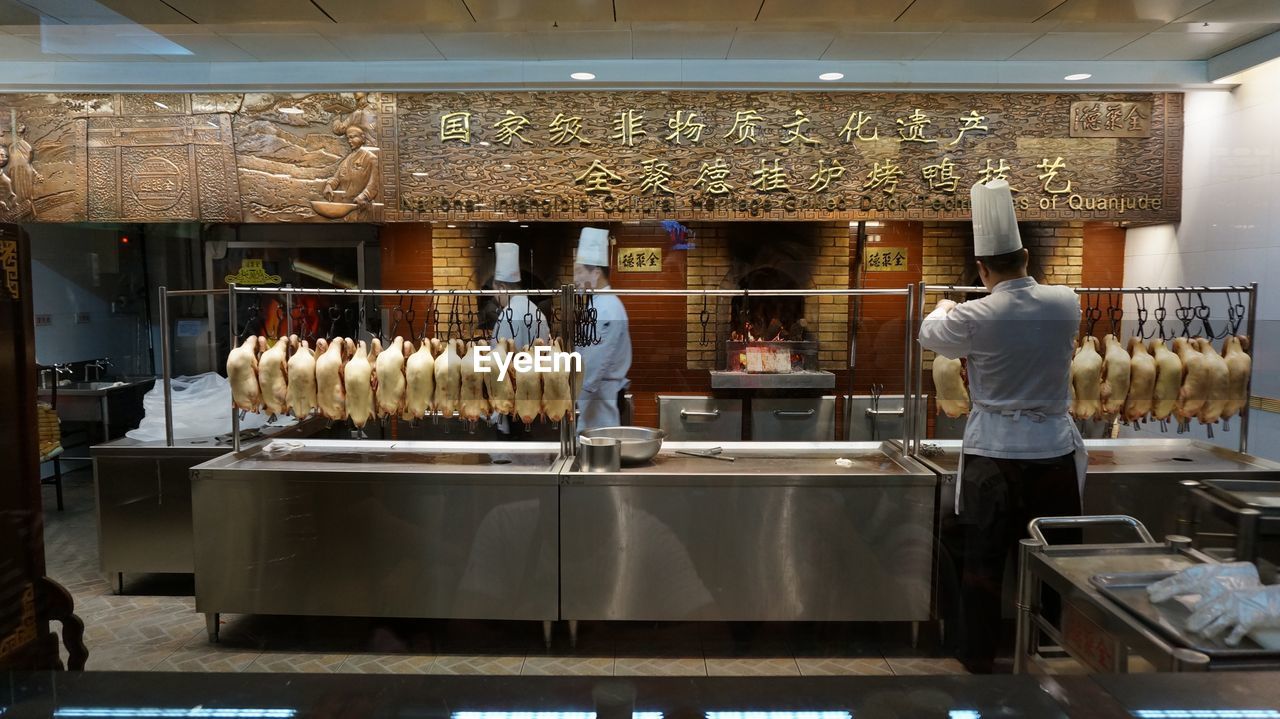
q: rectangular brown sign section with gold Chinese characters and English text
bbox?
[398,91,1181,220]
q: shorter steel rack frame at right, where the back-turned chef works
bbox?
[906,281,1258,457]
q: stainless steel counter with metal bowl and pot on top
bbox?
[561,441,937,632]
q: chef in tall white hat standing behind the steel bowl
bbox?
[573,228,631,432]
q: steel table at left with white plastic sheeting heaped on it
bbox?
[91,417,324,592]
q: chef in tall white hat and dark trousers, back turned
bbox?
[920,180,1088,673]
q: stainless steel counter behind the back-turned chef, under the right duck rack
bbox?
[915,438,1280,541]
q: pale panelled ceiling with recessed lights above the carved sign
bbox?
[0,0,1280,87]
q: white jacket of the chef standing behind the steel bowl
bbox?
[575,289,631,432]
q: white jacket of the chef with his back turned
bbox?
[920,278,1083,459]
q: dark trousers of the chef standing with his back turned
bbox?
[942,454,1080,672]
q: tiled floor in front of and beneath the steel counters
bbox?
[45,470,964,677]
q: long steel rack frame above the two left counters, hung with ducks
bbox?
[222,283,916,457]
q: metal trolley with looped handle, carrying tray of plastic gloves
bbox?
[1014,516,1280,673]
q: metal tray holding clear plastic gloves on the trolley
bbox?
[1091,572,1280,660]
